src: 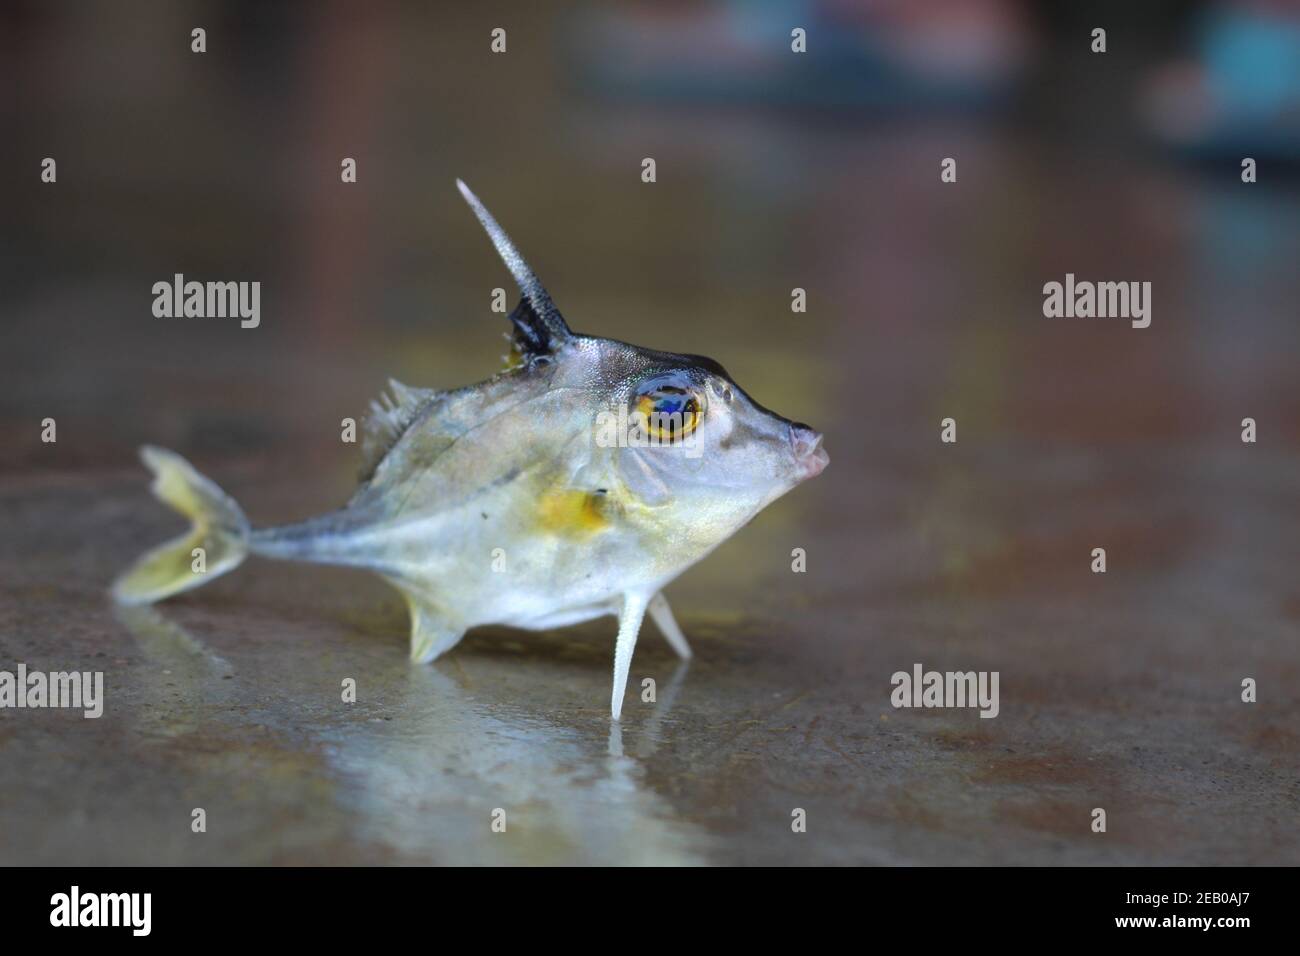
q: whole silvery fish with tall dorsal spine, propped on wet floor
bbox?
[112,179,829,721]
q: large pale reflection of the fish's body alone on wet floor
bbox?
[324,658,705,865]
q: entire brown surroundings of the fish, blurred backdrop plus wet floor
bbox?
[0,0,1300,864]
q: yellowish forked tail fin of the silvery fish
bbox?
[112,445,250,605]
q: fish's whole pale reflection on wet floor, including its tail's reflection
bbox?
[117,607,709,865]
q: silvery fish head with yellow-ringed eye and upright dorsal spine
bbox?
[458,181,829,567]
